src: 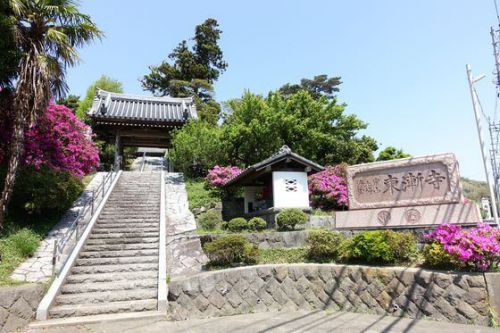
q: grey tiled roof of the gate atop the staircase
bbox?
[89,89,197,123]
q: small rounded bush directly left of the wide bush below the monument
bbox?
[307,231,344,261]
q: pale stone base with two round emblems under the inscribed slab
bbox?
[335,202,482,229]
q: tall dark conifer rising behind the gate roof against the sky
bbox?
[141,18,227,124]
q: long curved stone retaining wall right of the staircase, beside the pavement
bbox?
[168,264,500,325]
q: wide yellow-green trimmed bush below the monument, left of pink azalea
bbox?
[344,230,417,264]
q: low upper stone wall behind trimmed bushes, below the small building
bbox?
[200,230,309,249]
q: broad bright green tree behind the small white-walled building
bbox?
[223,90,377,166]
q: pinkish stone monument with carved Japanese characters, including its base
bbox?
[335,153,481,229]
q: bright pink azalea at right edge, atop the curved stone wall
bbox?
[425,224,500,271]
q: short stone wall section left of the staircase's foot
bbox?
[0,284,44,333]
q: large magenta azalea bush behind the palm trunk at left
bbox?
[0,103,99,177]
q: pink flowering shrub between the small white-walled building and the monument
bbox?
[308,165,348,210]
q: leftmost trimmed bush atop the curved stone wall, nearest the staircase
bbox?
[203,235,259,266]
